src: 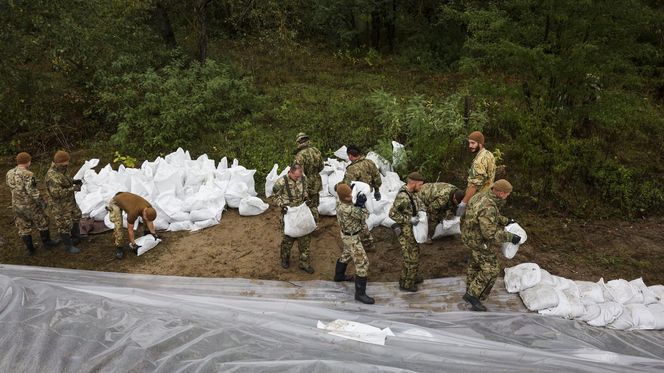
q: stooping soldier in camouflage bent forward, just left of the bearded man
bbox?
[417,183,464,244]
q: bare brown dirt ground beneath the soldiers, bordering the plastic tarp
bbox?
[0,159,664,285]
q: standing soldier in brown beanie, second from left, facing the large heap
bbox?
[44,150,81,254]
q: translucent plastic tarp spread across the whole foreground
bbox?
[0,265,664,372]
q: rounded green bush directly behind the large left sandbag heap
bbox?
[99,60,258,155]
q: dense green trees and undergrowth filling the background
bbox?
[0,0,664,217]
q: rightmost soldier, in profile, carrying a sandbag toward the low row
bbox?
[461,179,521,311]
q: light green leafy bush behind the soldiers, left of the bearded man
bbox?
[371,91,487,180]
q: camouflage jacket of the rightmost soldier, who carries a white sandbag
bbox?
[461,191,512,248]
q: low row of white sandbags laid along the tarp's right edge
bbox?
[505,263,664,330]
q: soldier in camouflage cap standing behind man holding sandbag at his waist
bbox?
[295,132,325,223]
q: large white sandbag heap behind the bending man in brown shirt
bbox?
[74,148,268,231]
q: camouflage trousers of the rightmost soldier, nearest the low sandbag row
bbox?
[466,245,500,300]
